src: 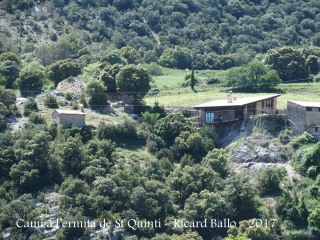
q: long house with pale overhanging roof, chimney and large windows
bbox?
[194,91,280,124]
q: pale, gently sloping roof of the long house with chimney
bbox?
[194,94,280,108]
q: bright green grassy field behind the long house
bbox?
[145,69,320,108]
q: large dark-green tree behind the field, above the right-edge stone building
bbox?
[265,47,308,82]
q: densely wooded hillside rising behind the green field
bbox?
[0,0,320,69]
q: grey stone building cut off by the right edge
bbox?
[287,101,320,139]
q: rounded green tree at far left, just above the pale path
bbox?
[18,62,45,95]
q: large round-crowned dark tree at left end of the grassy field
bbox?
[116,65,152,104]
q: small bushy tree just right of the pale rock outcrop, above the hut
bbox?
[86,80,108,107]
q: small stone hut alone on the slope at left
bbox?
[52,105,86,127]
